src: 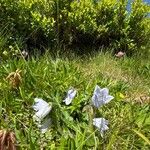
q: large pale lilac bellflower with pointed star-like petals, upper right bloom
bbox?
[92,85,114,108]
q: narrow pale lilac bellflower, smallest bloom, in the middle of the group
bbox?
[63,88,77,105]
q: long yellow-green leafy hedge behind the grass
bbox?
[0,0,150,53]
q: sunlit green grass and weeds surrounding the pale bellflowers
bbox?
[0,53,150,150]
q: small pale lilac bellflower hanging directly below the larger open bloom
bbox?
[93,118,109,137]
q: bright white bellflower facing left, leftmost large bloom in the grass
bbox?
[32,98,52,121]
